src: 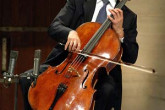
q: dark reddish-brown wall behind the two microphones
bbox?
[0,0,66,110]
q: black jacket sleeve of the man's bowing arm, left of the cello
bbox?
[48,0,75,43]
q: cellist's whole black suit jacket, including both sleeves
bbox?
[45,0,138,108]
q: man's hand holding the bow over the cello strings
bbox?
[65,31,81,51]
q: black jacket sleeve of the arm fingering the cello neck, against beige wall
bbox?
[121,15,139,63]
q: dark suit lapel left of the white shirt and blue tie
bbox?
[83,0,96,22]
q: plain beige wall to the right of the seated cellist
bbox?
[122,0,165,110]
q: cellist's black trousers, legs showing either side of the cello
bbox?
[20,65,115,110]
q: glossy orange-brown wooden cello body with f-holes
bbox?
[28,22,122,110]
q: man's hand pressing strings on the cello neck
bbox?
[108,8,124,38]
